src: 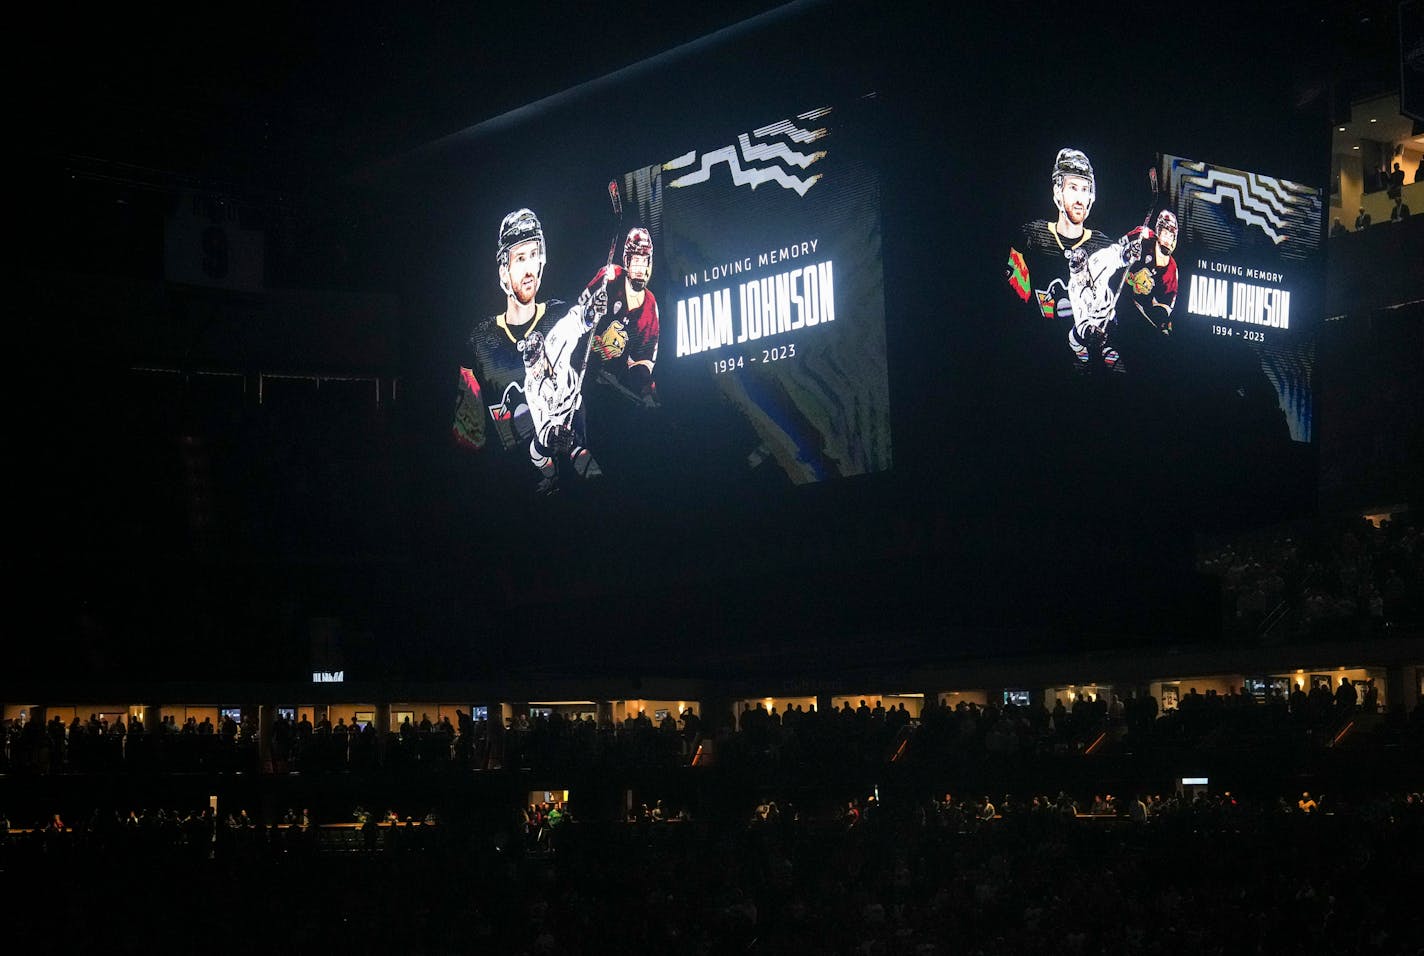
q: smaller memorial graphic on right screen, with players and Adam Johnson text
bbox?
[1004,145,1323,442]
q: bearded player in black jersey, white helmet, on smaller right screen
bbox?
[1005,147,1111,339]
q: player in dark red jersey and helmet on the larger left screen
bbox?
[585,227,658,405]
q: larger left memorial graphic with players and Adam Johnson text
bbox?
[451,97,891,496]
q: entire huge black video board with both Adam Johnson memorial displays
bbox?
[393,3,1324,626]
